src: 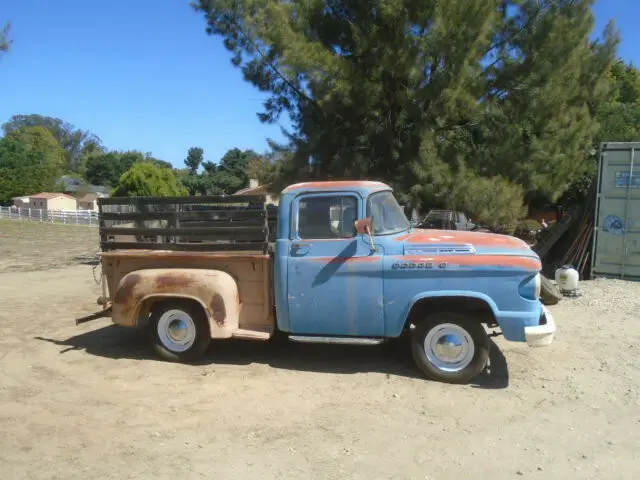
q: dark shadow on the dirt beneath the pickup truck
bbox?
[35,325,509,389]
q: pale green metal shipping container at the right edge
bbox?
[591,142,640,280]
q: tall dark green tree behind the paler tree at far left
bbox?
[2,114,101,172]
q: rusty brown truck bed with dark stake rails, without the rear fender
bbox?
[98,196,277,332]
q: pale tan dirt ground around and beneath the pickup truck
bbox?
[0,222,640,480]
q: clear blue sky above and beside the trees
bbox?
[0,0,640,166]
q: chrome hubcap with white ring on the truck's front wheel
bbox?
[424,323,475,372]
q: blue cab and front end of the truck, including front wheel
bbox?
[274,181,555,382]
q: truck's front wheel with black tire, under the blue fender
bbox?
[411,312,489,383]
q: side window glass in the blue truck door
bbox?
[298,195,358,240]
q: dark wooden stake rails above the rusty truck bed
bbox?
[98,195,278,254]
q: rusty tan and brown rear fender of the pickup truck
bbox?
[112,268,240,338]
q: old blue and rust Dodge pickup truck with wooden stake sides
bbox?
[78,181,556,383]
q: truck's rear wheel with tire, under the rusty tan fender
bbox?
[148,300,211,362]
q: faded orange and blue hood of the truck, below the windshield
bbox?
[395,229,537,257]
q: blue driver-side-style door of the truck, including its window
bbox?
[287,193,384,336]
